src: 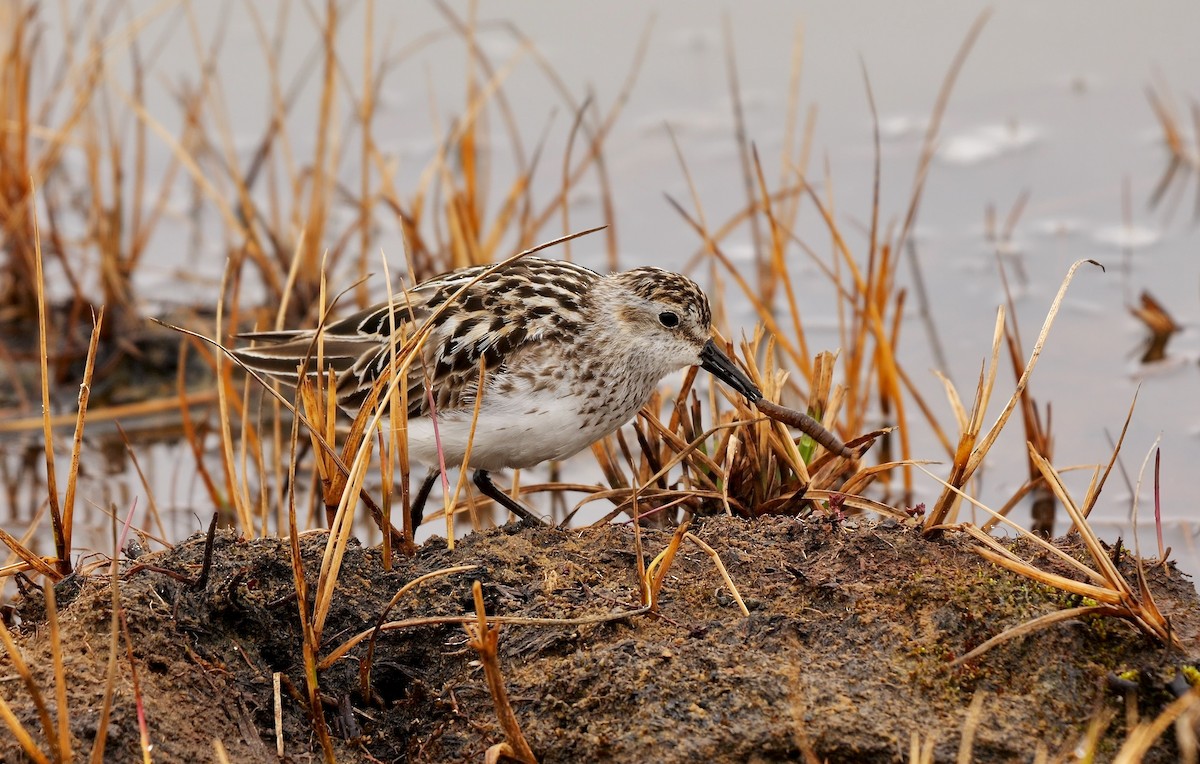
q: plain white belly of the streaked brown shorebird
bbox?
[408,396,640,470]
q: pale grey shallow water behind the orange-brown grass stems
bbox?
[9,0,1200,571]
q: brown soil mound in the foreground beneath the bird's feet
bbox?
[0,518,1200,762]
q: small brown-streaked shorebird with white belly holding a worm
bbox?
[234,257,844,522]
